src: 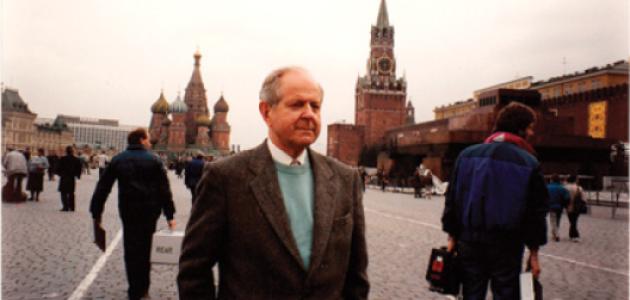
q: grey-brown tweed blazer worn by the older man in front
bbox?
[177,143,369,299]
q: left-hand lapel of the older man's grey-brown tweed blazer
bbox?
[249,142,304,266]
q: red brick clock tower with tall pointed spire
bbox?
[355,0,407,146]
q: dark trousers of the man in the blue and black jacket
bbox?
[457,241,524,300]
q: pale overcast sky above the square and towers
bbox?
[1,0,629,152]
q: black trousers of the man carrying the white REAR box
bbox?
[123,218,157,300]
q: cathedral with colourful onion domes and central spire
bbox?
[149,51,230,156]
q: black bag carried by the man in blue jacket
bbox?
[426,247,460,295]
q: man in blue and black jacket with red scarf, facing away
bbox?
[442,102,549,299]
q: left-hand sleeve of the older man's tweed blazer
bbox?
[177,164,227,299]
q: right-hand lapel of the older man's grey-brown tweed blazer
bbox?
[309,149,337,274]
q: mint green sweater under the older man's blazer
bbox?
[275,157,315,269]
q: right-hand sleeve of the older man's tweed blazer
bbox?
[343,172,370,299]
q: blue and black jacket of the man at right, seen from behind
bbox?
[442,142,549,249]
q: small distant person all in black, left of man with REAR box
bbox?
[57,146,81,211]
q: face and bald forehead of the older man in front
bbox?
[259,70,322,155]
